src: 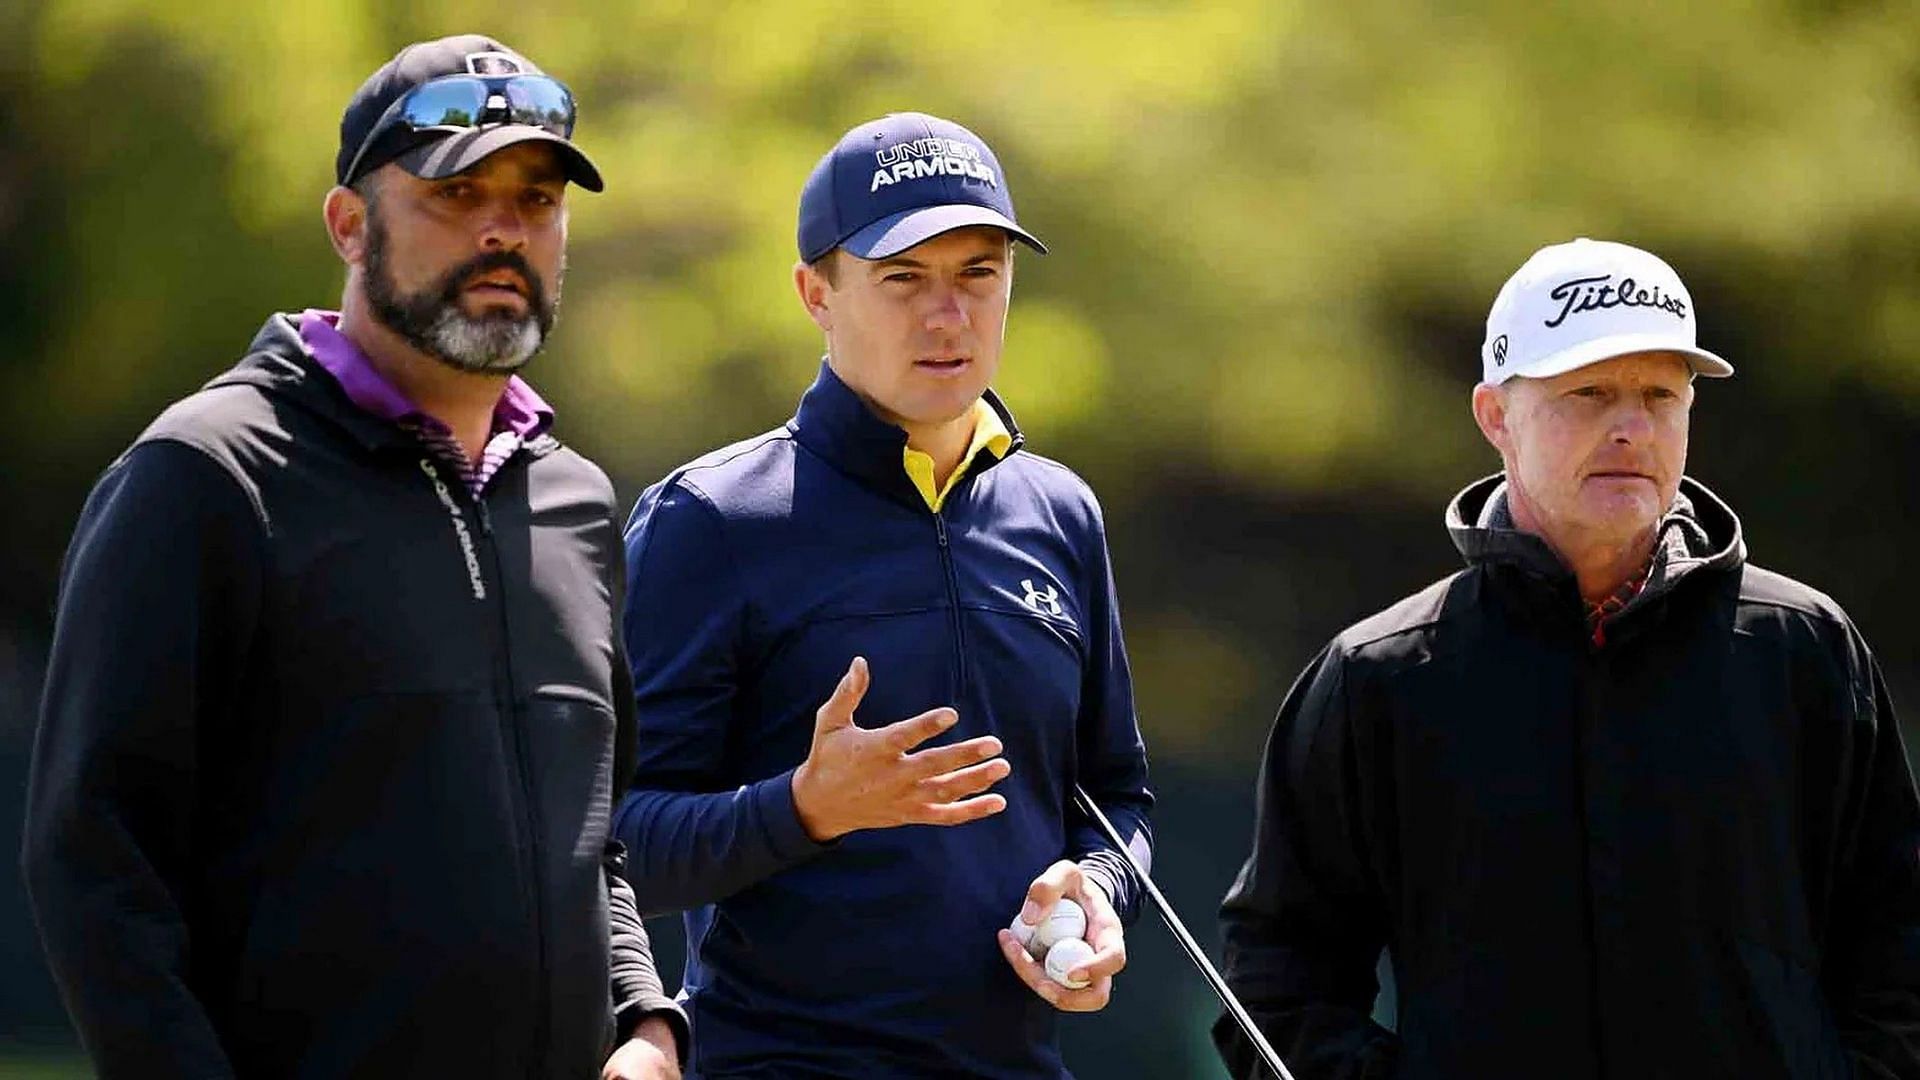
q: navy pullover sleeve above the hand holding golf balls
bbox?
[1068,491,1154,924]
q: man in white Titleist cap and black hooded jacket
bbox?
[1215,240,1920,1080]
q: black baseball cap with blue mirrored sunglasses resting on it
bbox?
[334,35,607,192]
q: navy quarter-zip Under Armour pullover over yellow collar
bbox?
[614,367,1152,1078]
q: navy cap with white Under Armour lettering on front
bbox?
[799,113,1046,263]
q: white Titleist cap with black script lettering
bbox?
[1480,238,1734,386]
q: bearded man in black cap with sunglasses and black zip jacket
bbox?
[23,35,684,1078]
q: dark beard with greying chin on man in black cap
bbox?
[365,211,566,375]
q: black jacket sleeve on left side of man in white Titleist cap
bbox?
[1213,648,1398,1080]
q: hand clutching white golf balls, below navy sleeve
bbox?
[1000,861,1127,1013]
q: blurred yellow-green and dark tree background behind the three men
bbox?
[0,0,1920,1076]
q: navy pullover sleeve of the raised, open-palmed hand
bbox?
[614,480,829,915]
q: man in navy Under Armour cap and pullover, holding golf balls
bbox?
[616,113,1152,1080]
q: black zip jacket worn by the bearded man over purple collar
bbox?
[23,317,684,1080]
